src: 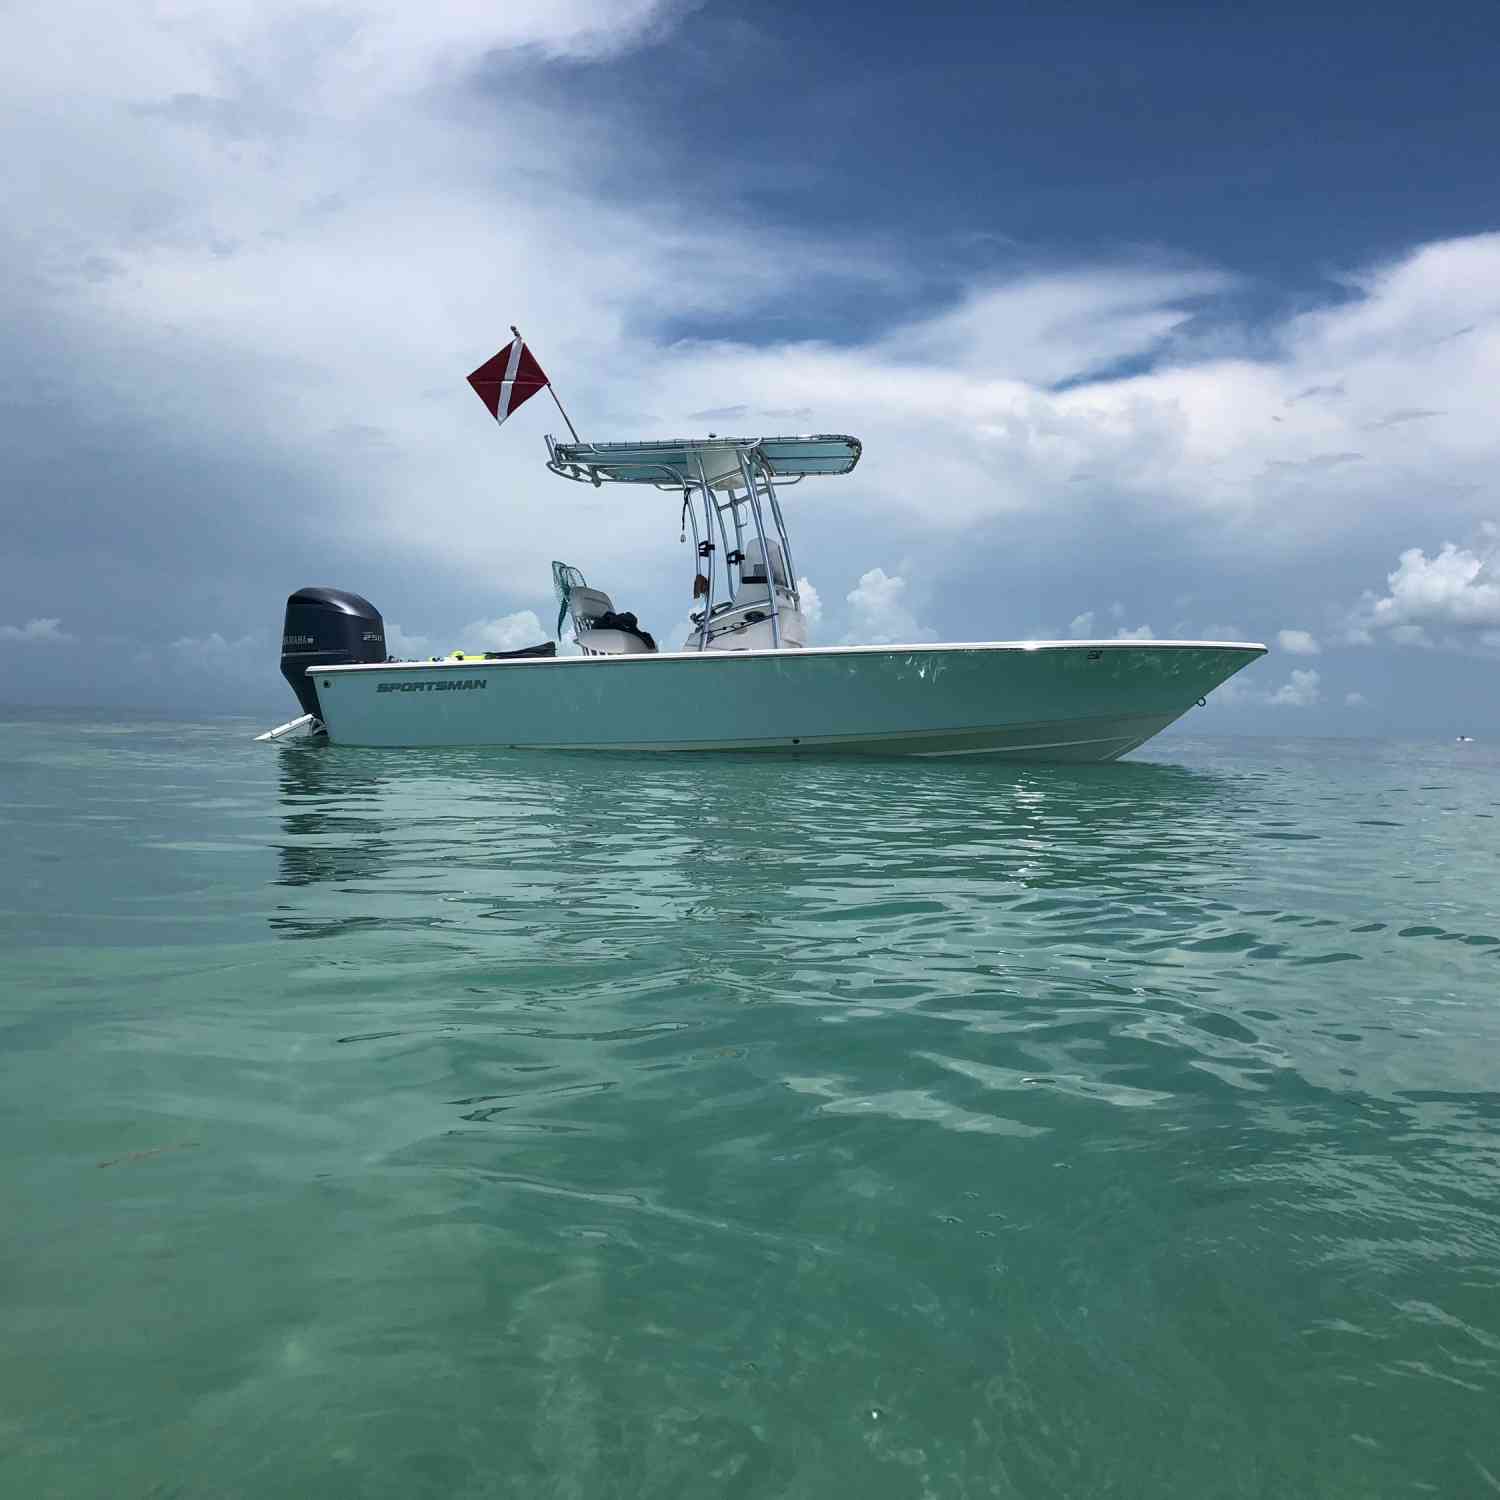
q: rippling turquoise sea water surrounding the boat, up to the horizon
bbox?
[0,714,1500,1500]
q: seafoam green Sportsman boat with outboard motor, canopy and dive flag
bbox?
[260,342,1266,762]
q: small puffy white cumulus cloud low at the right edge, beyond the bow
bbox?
[1344,522,1500,650]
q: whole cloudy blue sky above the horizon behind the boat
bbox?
[0,0,1500,738]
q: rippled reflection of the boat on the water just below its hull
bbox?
[272,740,1233,924]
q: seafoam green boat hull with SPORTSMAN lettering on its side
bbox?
[317,641,1265,761]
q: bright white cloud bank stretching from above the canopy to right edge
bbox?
[639,234,1500,557]
